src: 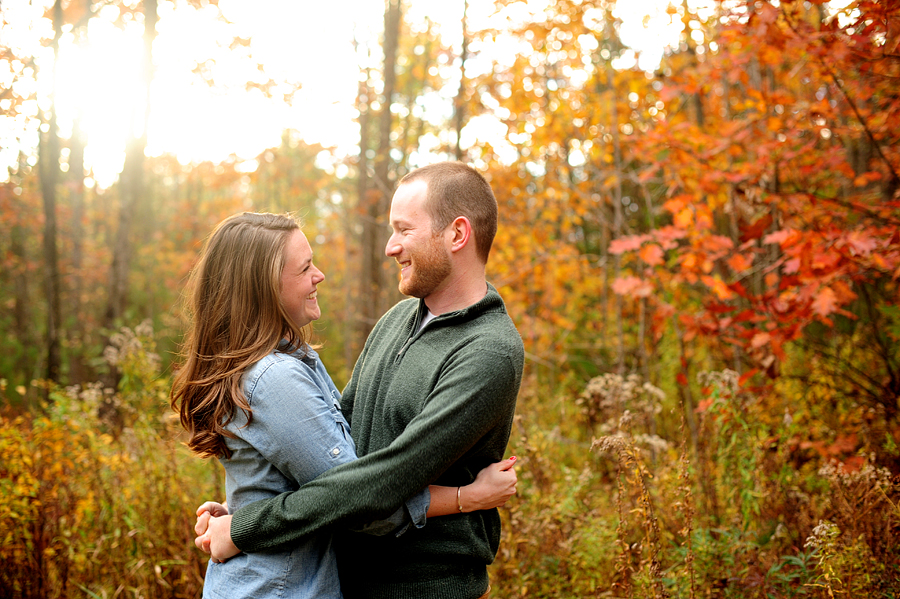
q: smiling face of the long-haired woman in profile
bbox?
[281,229,325,327]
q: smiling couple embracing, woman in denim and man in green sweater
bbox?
[172,162,524,599]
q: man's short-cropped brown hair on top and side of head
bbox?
[400,162,497,264]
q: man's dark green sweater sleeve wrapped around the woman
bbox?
[231,349,521,552]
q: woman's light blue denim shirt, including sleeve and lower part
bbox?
[203,349,430,599]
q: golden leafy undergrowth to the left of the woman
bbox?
[0,329,221,599]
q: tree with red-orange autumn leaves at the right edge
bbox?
[613,2,900,458]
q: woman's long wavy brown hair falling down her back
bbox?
[170,212,307,458]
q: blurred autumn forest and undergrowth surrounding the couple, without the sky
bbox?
[0,0,900,598]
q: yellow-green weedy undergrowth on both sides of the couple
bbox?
[0,327,900,599]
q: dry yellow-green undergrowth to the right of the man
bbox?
[493,370,900,599]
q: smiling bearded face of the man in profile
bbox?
[384,181,452,298]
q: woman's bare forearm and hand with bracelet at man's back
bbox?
[426,456,517,518]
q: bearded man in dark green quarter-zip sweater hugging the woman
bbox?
[198,163,524,599]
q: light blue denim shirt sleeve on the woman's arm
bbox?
[228,352,431,536]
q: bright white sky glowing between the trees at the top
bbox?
[0,0,712,187]
